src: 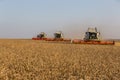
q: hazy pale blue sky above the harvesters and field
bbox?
[0,0,120,39]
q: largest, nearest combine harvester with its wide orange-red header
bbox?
[72,28,115,45]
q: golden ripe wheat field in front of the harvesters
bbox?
[0,39,120,80]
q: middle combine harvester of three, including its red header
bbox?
[46,31,71,42]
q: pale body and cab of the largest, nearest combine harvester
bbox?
[84,28,100,41]
